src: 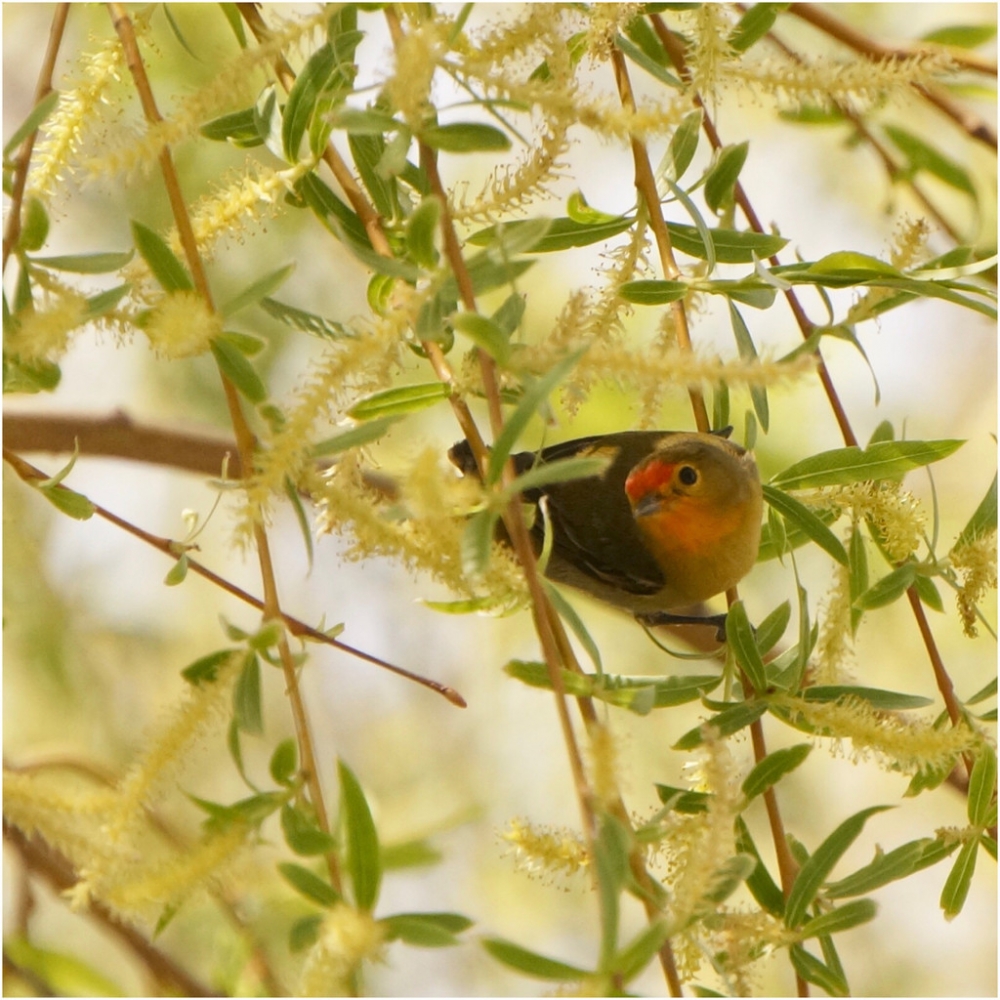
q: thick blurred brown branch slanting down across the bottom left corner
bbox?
[3,820,221,997]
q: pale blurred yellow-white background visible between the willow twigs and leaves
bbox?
[3,3,997,996]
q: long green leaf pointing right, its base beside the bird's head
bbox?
[771,440,965,490]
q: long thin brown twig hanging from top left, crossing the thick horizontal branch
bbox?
[108,3,341,892]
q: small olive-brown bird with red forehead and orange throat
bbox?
[448,428,763,625]
